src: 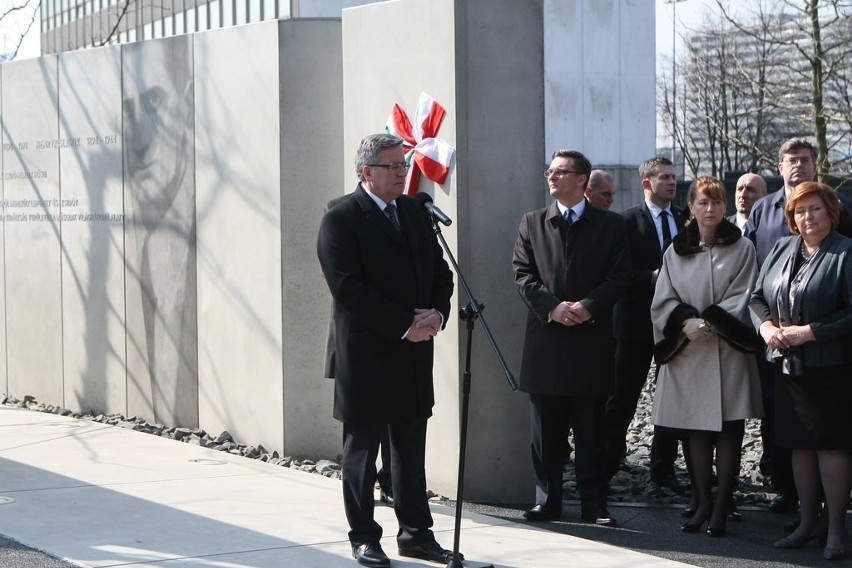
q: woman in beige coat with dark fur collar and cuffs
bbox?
[651,177,763,536]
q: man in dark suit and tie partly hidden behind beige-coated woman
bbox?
[606,157,686,492]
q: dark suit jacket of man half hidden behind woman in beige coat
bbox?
[613,201,685,342]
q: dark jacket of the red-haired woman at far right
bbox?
[749,231,852,367]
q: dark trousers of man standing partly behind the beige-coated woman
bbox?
[606,341,648,478]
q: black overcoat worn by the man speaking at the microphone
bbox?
[317,185,453,424]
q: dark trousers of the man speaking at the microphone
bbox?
[341,419,434,547]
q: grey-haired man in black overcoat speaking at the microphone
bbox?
[317,134,453,567]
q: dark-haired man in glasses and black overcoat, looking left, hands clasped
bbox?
[512,150,630,526]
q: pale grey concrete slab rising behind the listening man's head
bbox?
[543,0,656,211]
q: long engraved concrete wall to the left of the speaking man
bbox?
[0,19,343,456]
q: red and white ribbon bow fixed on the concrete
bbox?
[385,93,456,195]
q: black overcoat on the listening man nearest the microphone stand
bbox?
[512,201,630,396]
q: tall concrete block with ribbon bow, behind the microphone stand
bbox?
[343,0,544,501]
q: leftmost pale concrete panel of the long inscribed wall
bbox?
[2,56,63,404]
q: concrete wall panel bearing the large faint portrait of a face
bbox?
[121,35,198,426]
